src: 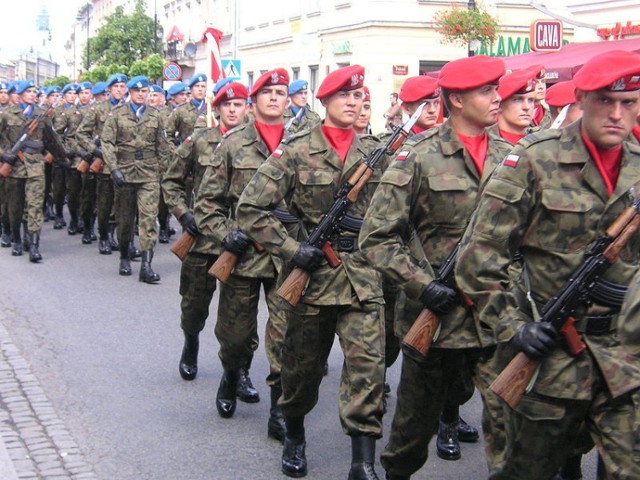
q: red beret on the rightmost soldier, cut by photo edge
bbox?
[573,50,640,92]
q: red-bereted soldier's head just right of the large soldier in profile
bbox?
[489,70,536,145]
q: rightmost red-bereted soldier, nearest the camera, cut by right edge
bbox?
[456,50,640,480]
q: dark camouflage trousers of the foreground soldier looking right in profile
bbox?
[380,348,504,476]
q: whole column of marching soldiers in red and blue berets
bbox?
[0,47,640,480]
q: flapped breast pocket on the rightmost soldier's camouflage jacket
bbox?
[528,189,602,253]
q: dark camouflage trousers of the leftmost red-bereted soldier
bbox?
[180,252,218,335]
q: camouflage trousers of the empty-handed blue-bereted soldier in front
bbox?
[114,181,160,252]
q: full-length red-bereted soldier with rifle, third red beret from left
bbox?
[237,65,385,480]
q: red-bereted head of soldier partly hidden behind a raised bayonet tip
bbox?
[399,75,440,134]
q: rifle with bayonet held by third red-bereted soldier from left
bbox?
[276,103,425,306]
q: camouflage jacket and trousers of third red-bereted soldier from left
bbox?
[235,125,386,437]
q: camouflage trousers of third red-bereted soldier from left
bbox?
[278,296,385,438]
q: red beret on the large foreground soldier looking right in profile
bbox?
[438,55,505,91]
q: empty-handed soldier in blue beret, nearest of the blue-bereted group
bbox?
[101,76,171,283]
